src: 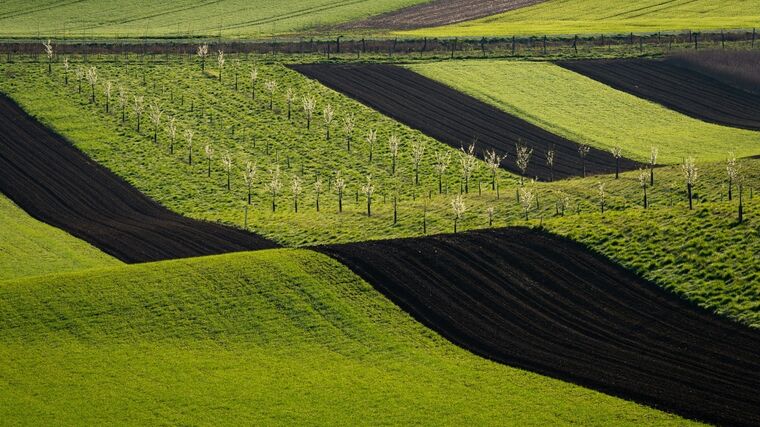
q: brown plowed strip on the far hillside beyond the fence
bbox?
[338,0,546,30]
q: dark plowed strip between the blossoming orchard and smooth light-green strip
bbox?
[292,64,637,181]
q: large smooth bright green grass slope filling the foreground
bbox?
[0,249,687,425]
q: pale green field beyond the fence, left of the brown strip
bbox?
[0,0,428,39]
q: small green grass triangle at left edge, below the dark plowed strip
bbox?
[0,194,120,281]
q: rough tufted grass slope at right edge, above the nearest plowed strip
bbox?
[543,199,760,328]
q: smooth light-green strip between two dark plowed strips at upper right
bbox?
[411,61,760,163]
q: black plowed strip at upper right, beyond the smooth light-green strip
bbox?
[558,59,760,130]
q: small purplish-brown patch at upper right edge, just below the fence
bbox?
[664,49,760,95]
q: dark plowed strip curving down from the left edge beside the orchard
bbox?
[0,95,276,262]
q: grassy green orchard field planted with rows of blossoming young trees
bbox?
[0,56,760,326]
